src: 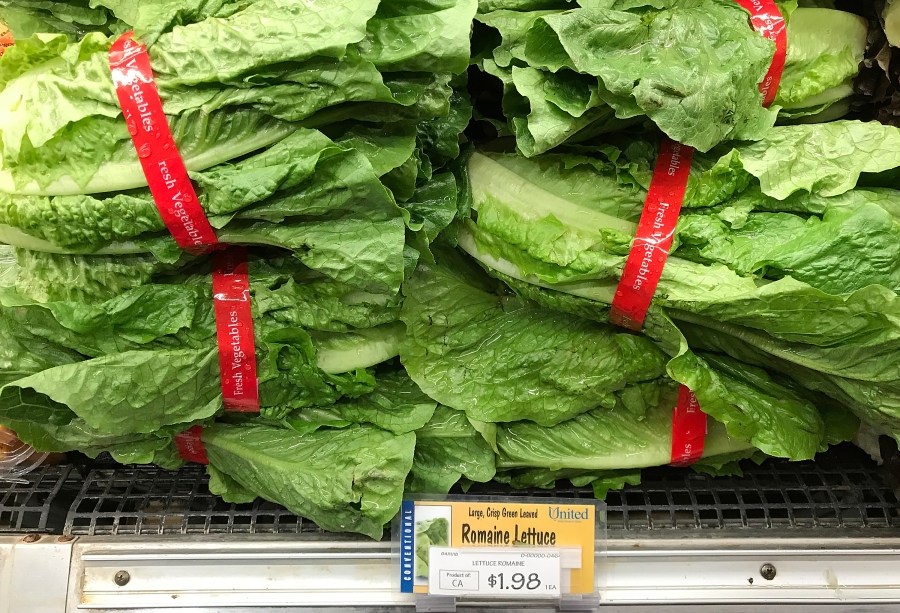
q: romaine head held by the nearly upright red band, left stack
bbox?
[0,251,404,440]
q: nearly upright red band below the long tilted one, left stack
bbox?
[213,247,259,413]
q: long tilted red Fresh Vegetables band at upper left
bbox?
[109,32,219,252]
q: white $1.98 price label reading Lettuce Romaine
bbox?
[428,547,561,598]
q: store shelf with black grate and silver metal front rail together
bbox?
[0,447,900,613]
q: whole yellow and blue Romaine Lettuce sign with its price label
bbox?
[394,498,603,599]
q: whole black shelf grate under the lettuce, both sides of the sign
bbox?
[0,445,900,536]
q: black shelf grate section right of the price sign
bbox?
[607,454,900,531]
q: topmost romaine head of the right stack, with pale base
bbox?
[475,0,867,156]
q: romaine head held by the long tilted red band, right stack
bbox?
[458,129,900,440]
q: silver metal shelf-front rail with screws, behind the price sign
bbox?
[0,535,900,613]
